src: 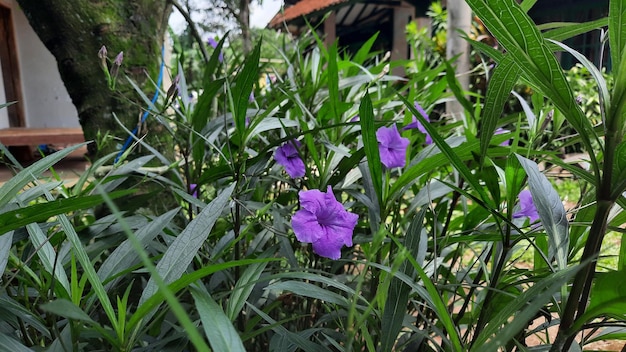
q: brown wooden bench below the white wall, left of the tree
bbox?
[0,127,85,147]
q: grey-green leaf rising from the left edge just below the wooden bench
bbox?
[0,143,87,206]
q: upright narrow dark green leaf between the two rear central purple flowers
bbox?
[359,92,382,204]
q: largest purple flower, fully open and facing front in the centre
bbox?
[291,186,359,259]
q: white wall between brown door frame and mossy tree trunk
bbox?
[0,0,79,127]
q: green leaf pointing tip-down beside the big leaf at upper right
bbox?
[479,54,521,159]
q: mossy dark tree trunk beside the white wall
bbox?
[17,0,171,157]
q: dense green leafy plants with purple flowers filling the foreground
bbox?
[0,0,626,352]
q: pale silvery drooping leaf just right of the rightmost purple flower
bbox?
[516,154,569,270]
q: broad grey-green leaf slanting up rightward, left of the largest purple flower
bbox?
[139,184,235,305]
